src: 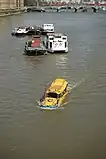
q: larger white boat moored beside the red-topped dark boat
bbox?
[44,33,68,52]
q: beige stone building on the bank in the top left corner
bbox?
[0,0,24,9]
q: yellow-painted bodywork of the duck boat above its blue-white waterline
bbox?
[42,78,70,106]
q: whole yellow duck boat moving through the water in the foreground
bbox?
[37,78,70,110]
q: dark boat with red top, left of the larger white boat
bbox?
[25,35,47,56]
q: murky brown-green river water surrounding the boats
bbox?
[0,12,106,159]
